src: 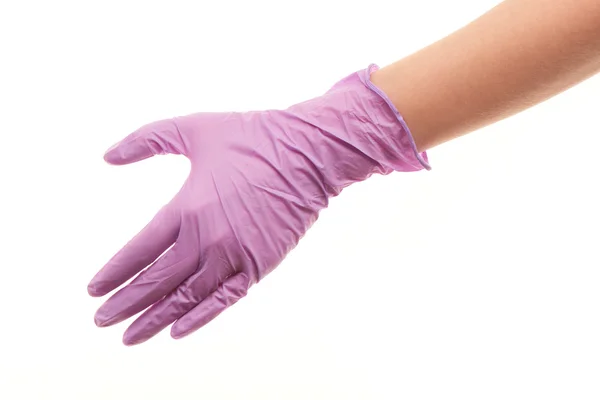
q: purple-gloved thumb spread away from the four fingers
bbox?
[104,119,186,165]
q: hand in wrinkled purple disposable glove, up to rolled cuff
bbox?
[88,65,429,345]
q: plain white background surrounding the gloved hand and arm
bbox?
[0,0,600,400]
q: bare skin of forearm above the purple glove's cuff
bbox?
[371,0,600,151]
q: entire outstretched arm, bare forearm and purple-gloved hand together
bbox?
[88,0,600,345]
